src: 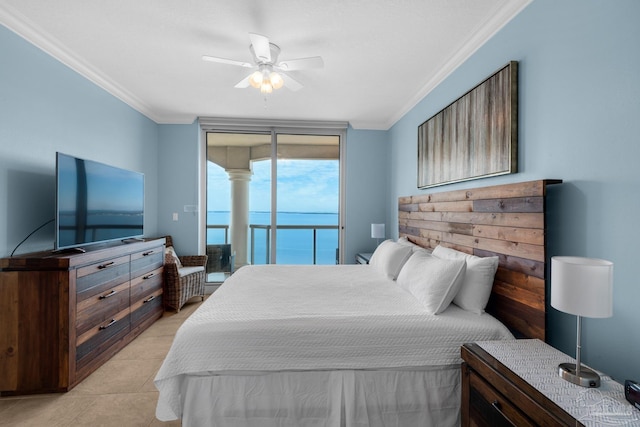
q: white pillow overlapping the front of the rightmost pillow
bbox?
[398,251,466,314]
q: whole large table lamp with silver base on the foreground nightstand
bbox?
[551,257,613,387]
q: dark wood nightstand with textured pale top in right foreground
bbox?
[461,339,640,427]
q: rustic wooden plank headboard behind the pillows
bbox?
[398,180,562,341]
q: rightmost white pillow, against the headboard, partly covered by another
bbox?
[433,245,499,314]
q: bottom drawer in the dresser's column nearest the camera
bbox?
[76,307,131,369]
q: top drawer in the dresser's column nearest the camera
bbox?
[76,255,130,302]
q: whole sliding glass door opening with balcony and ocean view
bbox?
[205,123,343,282]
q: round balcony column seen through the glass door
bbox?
[227,169,251,269]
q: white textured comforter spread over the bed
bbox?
[155,265,513,420]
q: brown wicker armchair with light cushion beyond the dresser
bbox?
[162,236,207,311]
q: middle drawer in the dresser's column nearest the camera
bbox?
[76,281,130,337]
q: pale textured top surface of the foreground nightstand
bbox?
[463,339,640,426]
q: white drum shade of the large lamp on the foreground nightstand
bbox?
[551,257,613,317]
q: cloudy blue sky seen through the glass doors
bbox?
[207,159,340,213]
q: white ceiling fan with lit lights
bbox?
[202,33,324,94]
